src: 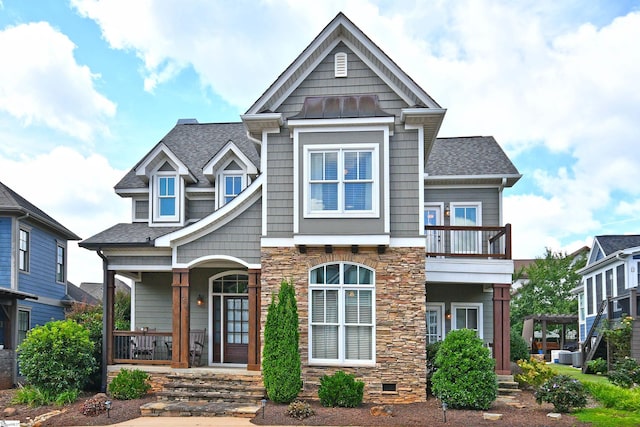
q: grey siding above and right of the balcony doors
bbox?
[424,187,502,226]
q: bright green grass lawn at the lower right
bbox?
[548,363,640,427]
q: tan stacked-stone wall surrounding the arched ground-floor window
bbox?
[261,247,427,403]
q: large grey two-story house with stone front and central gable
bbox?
[81,13,520,402]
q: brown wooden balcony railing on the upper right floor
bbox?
[424,224,511,259]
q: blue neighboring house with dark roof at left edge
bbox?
[0,182,80,389]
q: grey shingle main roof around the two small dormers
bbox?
[115,122,260,189]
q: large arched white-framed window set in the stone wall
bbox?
[309,263,375,365]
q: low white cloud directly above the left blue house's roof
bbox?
[0,147,131,284]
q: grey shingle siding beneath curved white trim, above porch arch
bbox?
[177,200,262,264]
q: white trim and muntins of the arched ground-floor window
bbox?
[307,262,376,367]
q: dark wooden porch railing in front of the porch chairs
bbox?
[113,330,172,365]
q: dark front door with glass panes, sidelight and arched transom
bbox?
[211,273,249,364]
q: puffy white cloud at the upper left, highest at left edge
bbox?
[0,22,116,145]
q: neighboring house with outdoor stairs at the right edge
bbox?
[576,235,640,369]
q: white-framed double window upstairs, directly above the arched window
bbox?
[306,146,378,216]
